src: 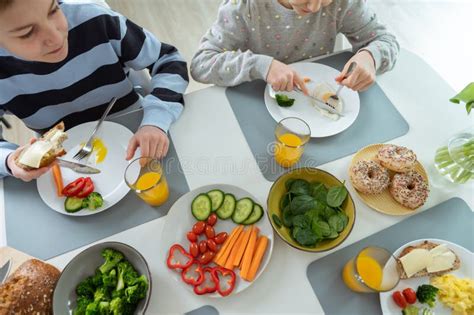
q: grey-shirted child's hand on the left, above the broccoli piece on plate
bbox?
[267,59,308,95]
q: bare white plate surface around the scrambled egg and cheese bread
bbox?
[380,238,474,315]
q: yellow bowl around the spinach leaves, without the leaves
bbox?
[267,167,355,253]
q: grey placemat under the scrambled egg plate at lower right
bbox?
[306,198,474,315]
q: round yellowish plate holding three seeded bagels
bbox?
[349,144,429,215]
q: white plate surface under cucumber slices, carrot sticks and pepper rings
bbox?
[161,184,273,297]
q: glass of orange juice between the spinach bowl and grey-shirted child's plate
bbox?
[275,117,311,167]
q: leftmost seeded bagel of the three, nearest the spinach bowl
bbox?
[349,161,390,195]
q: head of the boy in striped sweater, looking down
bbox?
[0,0,68,63]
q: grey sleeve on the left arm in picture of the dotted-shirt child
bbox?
[191,0,273,86]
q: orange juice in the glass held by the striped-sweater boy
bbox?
[135,172,169,206]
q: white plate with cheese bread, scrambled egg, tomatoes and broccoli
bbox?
[380,239,474,315]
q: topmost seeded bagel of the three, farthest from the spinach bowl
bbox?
[375,144,416,173]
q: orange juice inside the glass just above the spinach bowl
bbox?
[275,133,303,167]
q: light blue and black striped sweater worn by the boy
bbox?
[0,3,188,177]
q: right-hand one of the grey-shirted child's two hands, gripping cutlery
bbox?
[336,50,375,91]
